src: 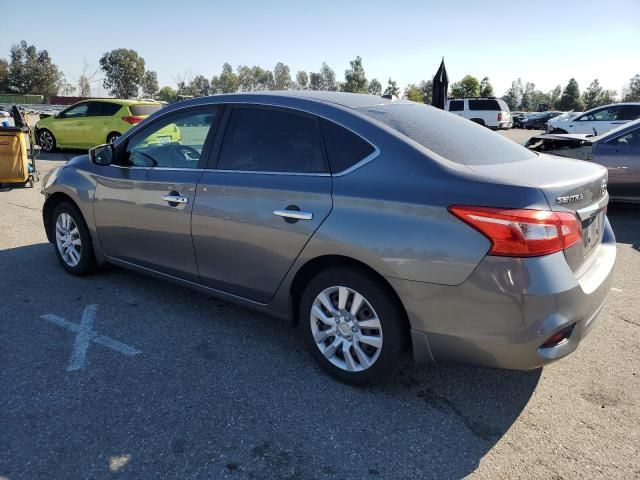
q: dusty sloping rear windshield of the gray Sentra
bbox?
[357,103,535,165]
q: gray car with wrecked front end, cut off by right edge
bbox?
[525,120,640,203]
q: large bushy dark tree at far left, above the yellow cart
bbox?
[7,40,63,99]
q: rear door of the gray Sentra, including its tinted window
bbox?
[192,105,332,303]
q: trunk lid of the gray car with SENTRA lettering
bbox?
[467,154,609,272]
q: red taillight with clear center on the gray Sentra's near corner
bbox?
[449,205,581,257]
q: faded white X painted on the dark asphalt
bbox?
[40,305,140,372]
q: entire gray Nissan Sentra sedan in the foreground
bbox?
[43,91,616,385]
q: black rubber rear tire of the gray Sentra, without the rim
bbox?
[299,266,409,386]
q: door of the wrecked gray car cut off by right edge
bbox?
[594,127,640,201]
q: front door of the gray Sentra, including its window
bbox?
[94,107,217,281]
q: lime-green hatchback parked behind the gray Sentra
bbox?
[35,98,166,152]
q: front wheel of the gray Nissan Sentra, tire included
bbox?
[51,202,95,275]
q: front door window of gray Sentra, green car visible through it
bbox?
[124,109,216,168]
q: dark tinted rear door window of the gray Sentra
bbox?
[218,108,327,173]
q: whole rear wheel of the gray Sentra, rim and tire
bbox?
[300,267,407,385]
